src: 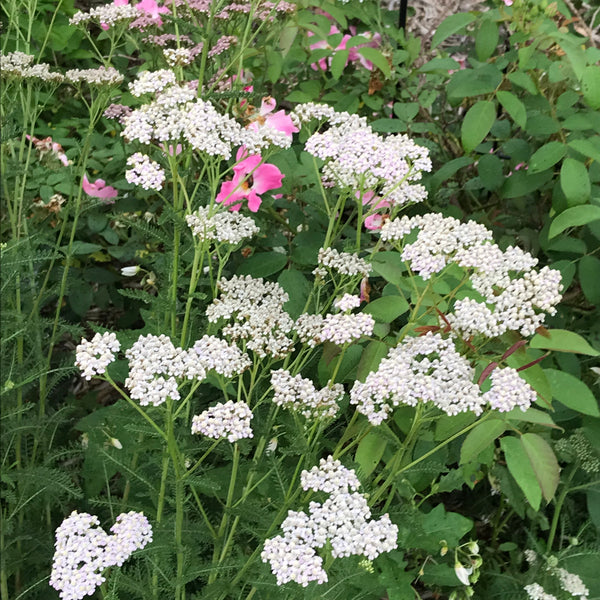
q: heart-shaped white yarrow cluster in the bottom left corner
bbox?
[49,511,152,600]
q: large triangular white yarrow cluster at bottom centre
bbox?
[261,456,398,587]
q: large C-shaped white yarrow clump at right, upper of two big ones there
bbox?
[381,213,562,337]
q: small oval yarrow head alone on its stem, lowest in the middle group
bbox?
[192,400,254,443]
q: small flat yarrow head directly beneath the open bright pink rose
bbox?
[185,207,260,245]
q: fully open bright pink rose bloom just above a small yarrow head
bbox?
[215,146,284,212]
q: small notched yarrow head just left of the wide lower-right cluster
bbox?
[271,369,344,419]
